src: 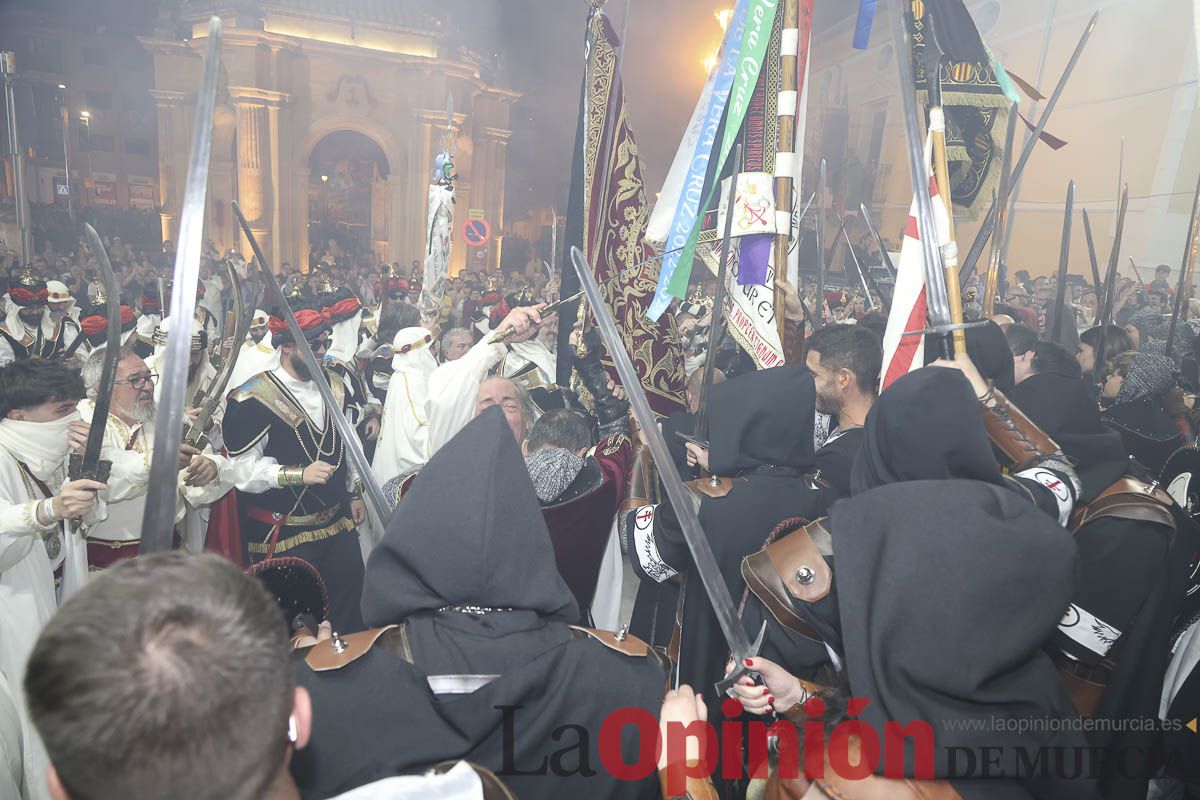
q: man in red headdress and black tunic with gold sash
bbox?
[224,303,366,633]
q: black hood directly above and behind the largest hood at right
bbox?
[850,367,1012,494]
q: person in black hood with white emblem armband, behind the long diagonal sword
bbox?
[620,365,834,708]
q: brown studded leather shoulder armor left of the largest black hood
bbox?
[742,517,833,642]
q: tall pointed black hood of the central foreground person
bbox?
[362,408,580,627]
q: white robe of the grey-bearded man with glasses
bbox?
[79,399,233,553]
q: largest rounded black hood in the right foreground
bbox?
[829,479,1094,799]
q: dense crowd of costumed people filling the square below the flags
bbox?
[0,205,1200,800]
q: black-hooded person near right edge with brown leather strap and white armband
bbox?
[1009,342,1196,799]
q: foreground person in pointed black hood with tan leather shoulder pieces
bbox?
[292,409,665,800]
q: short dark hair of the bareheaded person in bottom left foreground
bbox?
[25,552,294,800]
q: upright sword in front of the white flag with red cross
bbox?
[892,0,954,359]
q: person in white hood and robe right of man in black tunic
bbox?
[372,327,438,486]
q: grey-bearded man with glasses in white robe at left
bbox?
[79,348,233,572]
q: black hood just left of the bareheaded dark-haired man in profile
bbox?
[708,365,816,475]
